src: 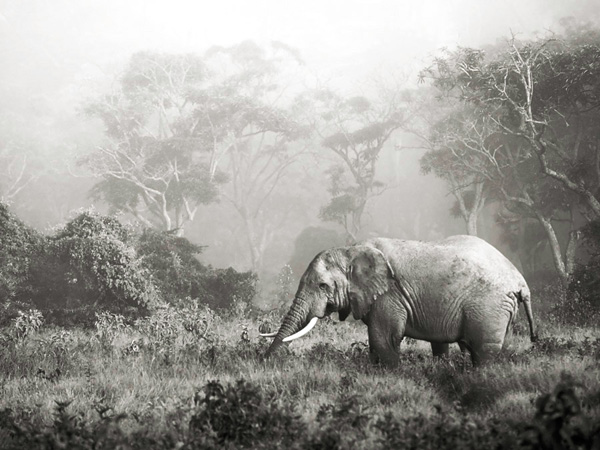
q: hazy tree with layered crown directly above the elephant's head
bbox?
[302,89,404,243]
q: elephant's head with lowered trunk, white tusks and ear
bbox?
[262,245,394,357]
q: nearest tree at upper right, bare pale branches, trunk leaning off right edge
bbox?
[422,22,600,223]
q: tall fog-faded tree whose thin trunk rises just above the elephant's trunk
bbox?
[190,42,308,273]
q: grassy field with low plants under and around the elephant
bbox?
[0,298,600,449]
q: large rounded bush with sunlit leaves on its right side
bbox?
[32,211,156,324]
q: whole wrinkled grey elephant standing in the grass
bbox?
[267,236,536,367]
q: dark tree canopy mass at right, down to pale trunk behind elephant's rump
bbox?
[421,22,600,283]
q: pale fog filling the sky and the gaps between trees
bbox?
[0,0,600,280]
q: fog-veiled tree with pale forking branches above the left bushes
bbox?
[83,53,226,236]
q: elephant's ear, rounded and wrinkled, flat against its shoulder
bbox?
[348,245,394,320]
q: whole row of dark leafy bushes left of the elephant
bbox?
[0,204,257,326]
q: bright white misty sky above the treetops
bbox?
[0,0,600,91]
